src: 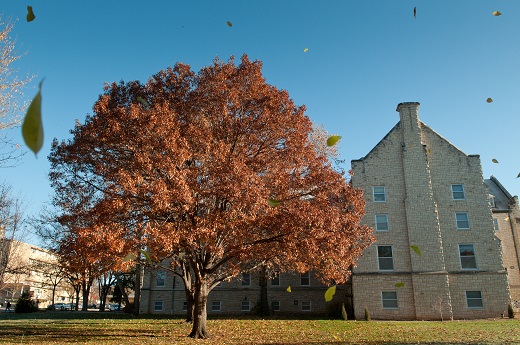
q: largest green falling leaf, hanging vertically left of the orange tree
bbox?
[22,80,43,155]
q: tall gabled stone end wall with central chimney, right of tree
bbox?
[352,102,518,320]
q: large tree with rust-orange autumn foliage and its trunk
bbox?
[49,55,372,338]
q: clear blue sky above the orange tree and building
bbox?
[0,0,520,230]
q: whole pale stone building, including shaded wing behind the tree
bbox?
[140,102,520,320]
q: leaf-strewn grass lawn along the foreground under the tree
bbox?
[0,312,520,345]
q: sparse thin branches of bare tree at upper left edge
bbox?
[0,17,33,168]
